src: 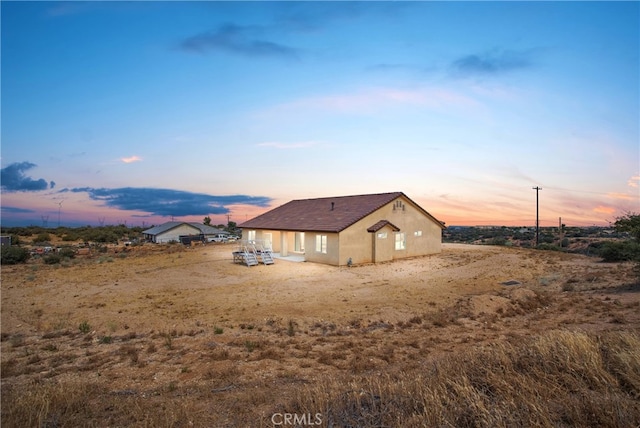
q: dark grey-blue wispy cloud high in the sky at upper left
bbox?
[180,24,299,59]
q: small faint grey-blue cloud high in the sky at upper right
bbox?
[450,49,533,77]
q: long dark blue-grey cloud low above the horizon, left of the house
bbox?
[60,187,271,217]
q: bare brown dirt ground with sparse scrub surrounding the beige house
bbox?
[1,244,640,427]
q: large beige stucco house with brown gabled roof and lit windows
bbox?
[239,192,445,266]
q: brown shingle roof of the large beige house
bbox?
[239,192,440,232]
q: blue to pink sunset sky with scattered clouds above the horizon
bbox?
[0,1,640,227]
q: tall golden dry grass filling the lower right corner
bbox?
[287,331,640,427]
